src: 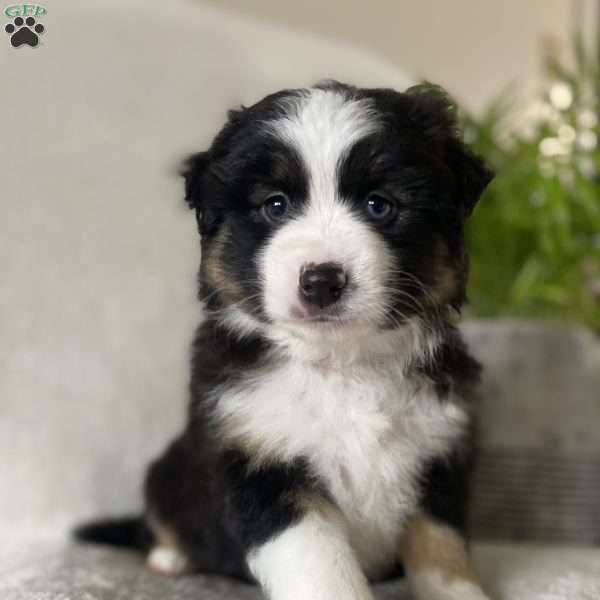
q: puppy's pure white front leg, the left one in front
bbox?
[248,505,372,600]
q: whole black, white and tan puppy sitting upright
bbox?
[79,82,492,600]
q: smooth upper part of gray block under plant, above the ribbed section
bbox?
[463,320,600,454]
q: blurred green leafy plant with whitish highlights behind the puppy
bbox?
[463,37,600,330]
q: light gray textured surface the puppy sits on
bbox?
[0,544,600,600]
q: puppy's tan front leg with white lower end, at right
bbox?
[401,514,489,600]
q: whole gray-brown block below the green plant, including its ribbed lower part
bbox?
[463,320,600,544]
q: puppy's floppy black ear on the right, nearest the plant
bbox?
[405,83,494,217]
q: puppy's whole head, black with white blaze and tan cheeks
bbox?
[184,83,491,336]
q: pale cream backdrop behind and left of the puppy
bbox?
[0,0,408,544]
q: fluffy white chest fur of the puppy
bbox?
[215,359,467,573]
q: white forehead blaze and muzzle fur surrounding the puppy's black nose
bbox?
[259,89,392,330]
